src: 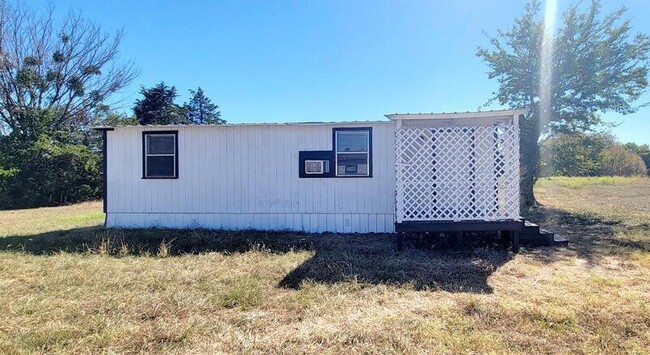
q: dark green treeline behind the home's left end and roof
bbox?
[0,82,226,209]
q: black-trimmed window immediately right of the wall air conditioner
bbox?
[334,128,372,177]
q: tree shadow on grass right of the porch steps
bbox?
[525,207,650,265]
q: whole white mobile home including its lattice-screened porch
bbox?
[98,110,524,239]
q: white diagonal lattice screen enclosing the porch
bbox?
[395,125,519,223]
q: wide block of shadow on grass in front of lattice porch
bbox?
[280,235,512,293]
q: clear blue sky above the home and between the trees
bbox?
[28,0,650,143]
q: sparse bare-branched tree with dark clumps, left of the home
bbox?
[0,1,136,140]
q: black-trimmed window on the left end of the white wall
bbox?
[142,131,178,179]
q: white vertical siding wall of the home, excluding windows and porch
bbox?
[106,122,395,233]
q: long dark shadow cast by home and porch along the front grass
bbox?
[0,227,512,293]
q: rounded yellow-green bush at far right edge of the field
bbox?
[599,145,648,176]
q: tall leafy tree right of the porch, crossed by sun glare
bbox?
[477,0,650,207]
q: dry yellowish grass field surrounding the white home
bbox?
[0,178,650,354]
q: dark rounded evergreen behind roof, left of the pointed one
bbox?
[133,82,187,125]
